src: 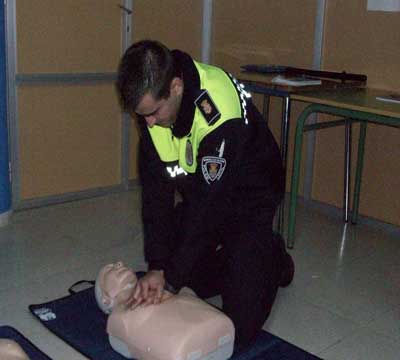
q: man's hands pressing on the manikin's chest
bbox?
[133,270,165,306]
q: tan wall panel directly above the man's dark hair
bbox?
[132,0,203,59]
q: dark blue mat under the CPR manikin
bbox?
[29,287,320,360]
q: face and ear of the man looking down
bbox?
[135,78,183,128]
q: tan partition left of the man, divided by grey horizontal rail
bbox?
[13,0,121,201]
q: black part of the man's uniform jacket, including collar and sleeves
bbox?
[138,50,284,288]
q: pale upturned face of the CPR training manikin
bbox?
[100,262,137,304]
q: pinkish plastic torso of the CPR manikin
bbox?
[107,291,234,360]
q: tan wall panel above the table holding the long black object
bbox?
[212,0,316,74]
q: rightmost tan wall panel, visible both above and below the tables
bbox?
[313,0,400,225]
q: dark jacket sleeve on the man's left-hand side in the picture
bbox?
[139,121,175,270]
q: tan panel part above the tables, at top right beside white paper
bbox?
[324,0,400,90]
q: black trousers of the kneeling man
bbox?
[176,206,282,350]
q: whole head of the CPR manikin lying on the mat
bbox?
[95,261,137,314]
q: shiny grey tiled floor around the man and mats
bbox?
[0,190,400,360]
